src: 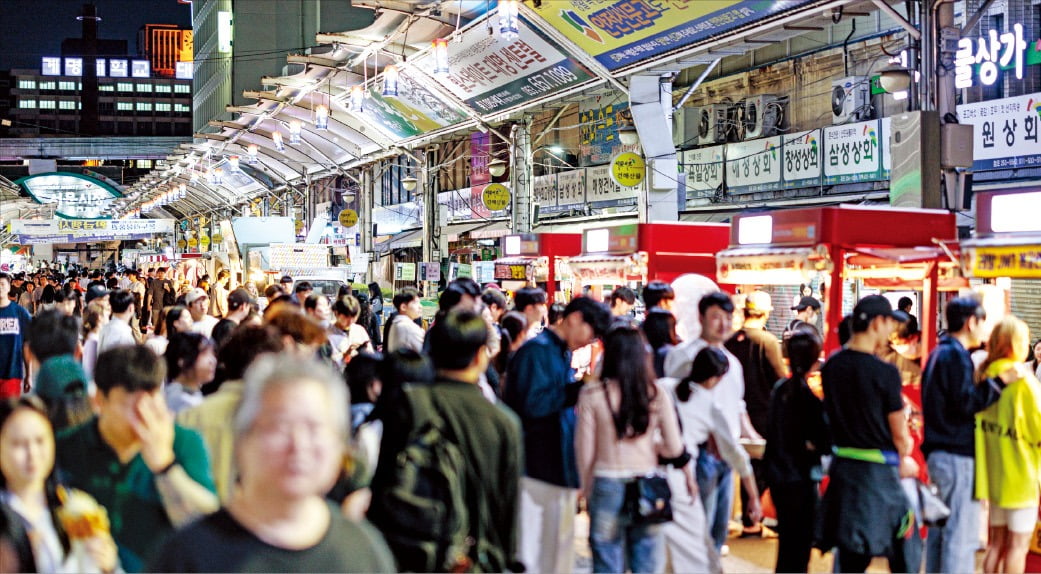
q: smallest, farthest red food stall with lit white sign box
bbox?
[494,233,582,302]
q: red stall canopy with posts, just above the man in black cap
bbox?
[716,205,958,354]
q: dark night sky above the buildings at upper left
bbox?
[0,0,192,70]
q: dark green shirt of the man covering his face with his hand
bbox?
[57,417,215,572]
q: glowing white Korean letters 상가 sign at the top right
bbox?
[955,22,1041,89]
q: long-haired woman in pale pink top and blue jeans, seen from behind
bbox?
[575,326,683,573]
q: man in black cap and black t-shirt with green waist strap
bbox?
[818,295,921,572]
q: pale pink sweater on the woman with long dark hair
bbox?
[575,381,683,496]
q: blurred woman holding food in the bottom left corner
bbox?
[0,396,117,572]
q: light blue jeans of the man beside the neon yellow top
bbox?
[925,451,980,573]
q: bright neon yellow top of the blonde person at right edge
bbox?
[975,359,1041,508]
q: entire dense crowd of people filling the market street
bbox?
[0,269,1041,572]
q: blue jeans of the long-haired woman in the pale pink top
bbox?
[589,477,665,574]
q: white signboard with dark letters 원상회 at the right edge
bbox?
[958,94,1041,171]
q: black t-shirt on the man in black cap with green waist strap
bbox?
[820,349,904,450]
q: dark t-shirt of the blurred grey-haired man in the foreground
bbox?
[148,504,395,572]
